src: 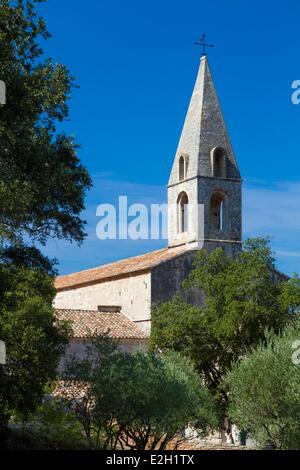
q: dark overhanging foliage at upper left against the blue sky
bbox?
[0,0,91,252]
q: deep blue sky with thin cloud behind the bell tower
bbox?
[39,0,300,274]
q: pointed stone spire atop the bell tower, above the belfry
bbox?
[169,56,240,184]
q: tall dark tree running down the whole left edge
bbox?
[0,0,91,426]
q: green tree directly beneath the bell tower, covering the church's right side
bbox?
[151,238,300,407]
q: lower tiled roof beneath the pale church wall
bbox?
[55,309,149,339]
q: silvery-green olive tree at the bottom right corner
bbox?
[224,316,300,450]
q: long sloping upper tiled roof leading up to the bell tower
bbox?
[55,246,186,290]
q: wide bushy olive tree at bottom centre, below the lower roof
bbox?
[65,338,217,450]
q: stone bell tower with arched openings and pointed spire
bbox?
[168,55,242,256]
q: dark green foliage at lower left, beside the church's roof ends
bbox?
[0,264,69,425]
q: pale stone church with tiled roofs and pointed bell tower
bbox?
[54,55,242,351]
